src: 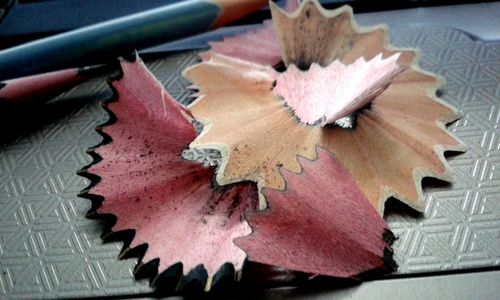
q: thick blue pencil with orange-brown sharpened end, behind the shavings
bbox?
[0,0,268,80]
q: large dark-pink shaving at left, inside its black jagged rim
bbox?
[88,57,258,276]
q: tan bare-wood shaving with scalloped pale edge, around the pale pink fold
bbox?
[185,0,466,214]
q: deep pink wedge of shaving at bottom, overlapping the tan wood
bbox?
[236,147,392,277]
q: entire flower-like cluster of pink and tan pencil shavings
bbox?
[83,0,464,287]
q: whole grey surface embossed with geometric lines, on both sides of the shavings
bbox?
[0,28,500,299]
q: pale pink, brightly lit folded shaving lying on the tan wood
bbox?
[274,54,404,126]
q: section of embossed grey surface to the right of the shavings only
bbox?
[387,28,500,273]
